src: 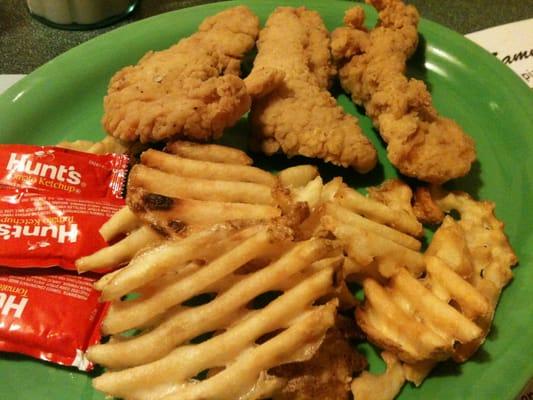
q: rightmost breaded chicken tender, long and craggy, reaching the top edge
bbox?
[331,0,476,183]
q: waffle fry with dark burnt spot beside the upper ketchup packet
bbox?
[77,141,312,272]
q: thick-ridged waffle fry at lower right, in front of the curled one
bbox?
[356,266,488,363]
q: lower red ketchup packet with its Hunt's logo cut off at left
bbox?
[0,268,108,371]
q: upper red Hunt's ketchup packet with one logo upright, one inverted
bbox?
[0,145,128,269]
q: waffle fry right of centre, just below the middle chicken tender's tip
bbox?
[312,179,424,282]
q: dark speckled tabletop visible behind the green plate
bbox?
[0,0,533,74]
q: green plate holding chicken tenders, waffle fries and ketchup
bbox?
[0,1,533,400]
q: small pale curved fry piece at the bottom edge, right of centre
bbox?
[352,352,405,400]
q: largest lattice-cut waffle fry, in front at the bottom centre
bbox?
[88,225,341,400]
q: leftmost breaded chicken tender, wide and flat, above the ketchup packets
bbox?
[102,6,259,143]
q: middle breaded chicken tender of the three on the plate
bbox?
[246,7,376,173]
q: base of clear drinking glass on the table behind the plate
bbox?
[26,0,138,30]
